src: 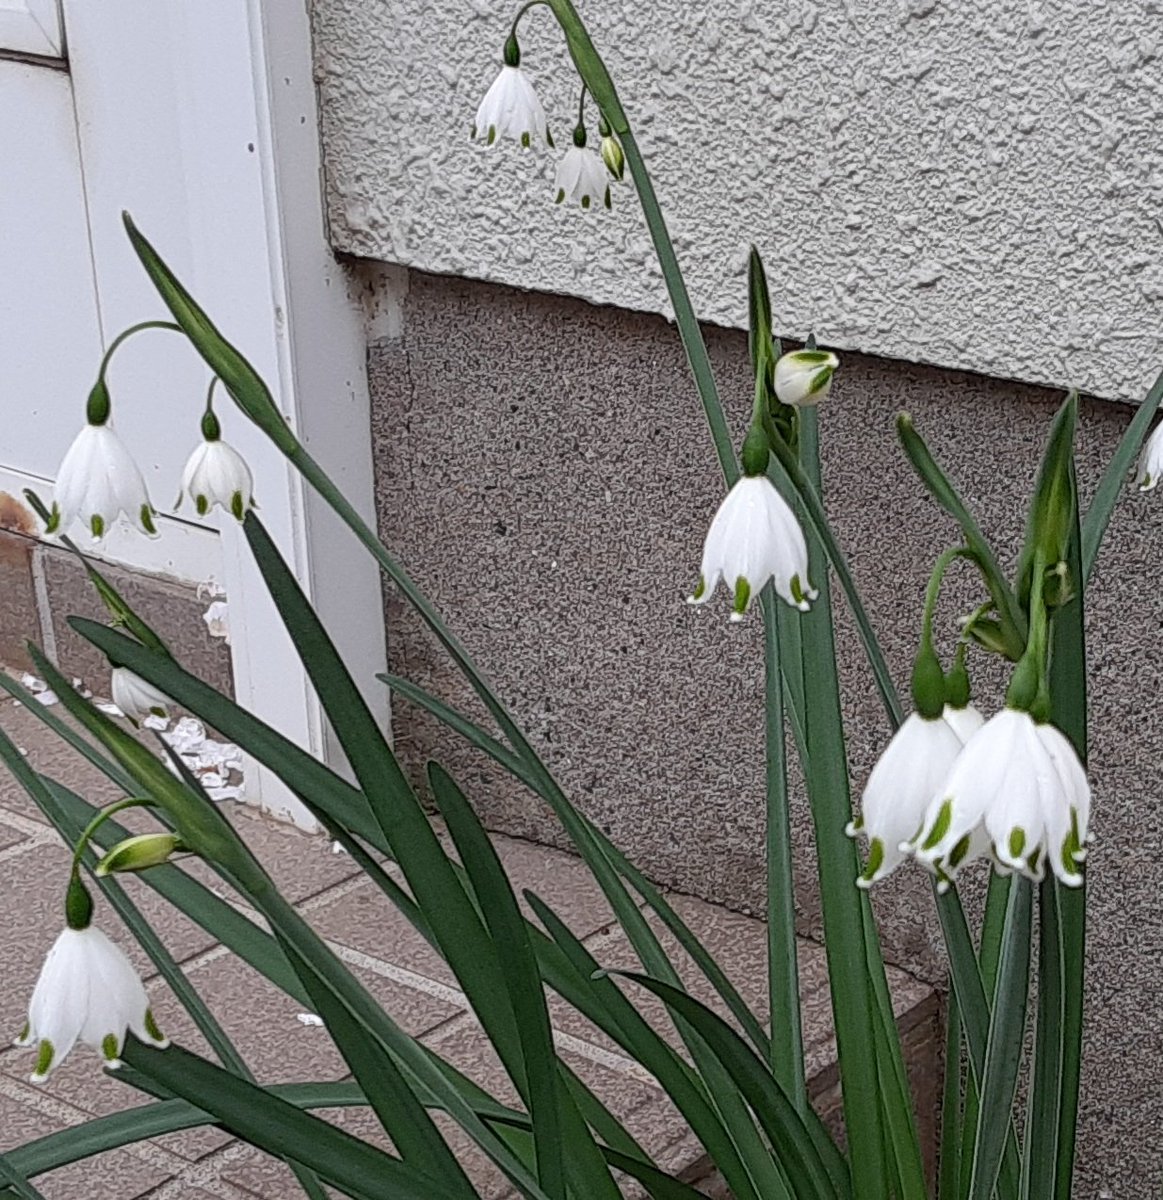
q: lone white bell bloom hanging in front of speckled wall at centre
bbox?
[689,475,819,620]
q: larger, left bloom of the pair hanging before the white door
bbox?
[46,422,157,541]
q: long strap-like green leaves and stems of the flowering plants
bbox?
[0,11,1163,1200]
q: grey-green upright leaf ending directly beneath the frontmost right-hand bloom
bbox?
[970,878,1033,1200]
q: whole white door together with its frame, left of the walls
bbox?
[0,0,388,824]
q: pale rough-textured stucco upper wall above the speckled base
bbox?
[314,0,1163,398]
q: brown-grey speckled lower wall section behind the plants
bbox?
[371,272,1163,1200]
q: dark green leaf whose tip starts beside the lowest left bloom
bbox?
[122,1039,458,1200]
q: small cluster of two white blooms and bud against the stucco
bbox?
[472,32,625,209]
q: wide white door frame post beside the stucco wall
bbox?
[64,0,388,826]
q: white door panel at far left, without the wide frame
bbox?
[0,12,222,582]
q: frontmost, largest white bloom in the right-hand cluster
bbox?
[909,708,1090,887]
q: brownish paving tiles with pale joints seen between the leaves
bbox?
[0,700,939,1200]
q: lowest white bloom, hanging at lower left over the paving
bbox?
[16,925,169,1084]
